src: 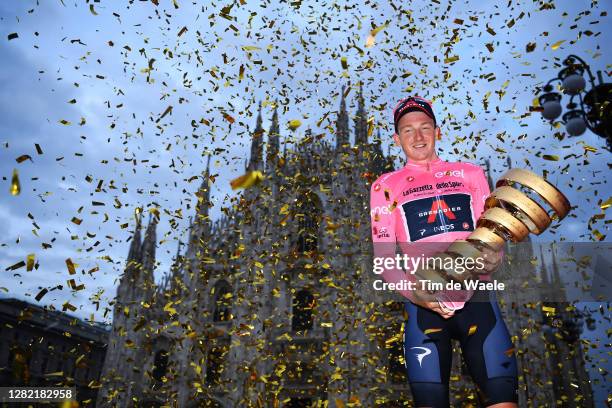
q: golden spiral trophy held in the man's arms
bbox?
[416,169,571,310]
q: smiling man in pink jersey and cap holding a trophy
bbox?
[370,97,518,408]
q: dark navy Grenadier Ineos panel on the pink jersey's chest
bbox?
[402,193,474,242]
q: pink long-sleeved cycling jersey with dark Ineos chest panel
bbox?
[370,158,490,308]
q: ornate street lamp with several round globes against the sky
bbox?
[538,55,612,151]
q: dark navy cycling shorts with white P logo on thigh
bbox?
[403,291,518,408]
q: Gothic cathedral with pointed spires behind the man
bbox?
[97,89,593,408]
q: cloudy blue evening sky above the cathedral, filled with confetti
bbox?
[0,0,612,400]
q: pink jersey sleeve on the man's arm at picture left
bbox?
[370,179,415,300]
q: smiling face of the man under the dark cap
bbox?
[393,111,440,164]
